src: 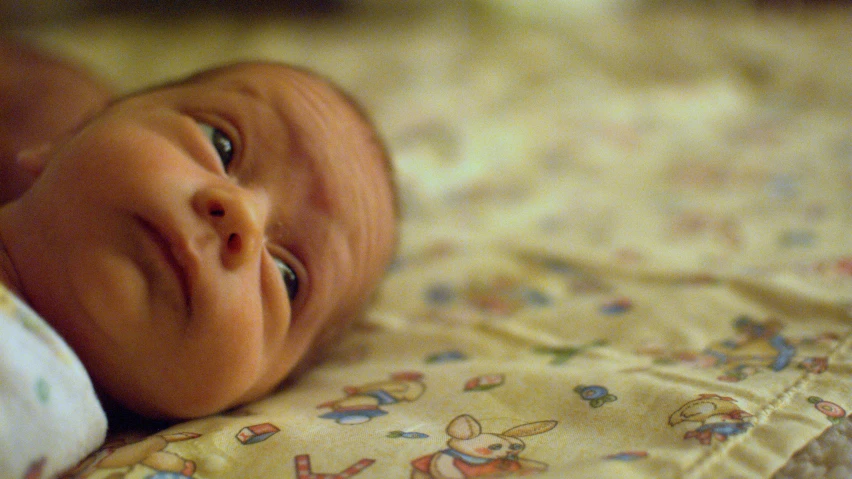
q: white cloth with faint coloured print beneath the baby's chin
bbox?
[0,286,106,478]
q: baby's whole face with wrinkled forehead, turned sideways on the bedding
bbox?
[16,64,395,417]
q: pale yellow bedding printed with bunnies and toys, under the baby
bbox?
[8,1,852,479]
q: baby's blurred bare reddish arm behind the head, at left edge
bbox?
[0,38,112,204]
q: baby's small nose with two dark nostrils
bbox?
[192,186,266,269]
